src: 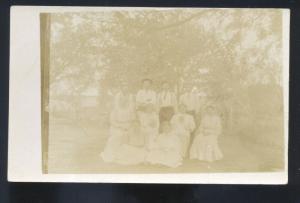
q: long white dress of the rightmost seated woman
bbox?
[190,115,223,162]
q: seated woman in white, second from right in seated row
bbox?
[171,104,196,157]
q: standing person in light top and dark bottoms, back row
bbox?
[158,82,177,130]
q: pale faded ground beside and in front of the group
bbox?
[48,117,282,173]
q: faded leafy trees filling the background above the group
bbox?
[50,9,282,130]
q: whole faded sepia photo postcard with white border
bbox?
[8,7,289,184]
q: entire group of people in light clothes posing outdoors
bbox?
[101,79,223,167]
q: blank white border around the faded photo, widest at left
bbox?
[8,6,290,184]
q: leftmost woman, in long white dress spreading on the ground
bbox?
[101,88,145,165]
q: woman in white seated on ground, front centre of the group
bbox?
[146,121,182,168]
